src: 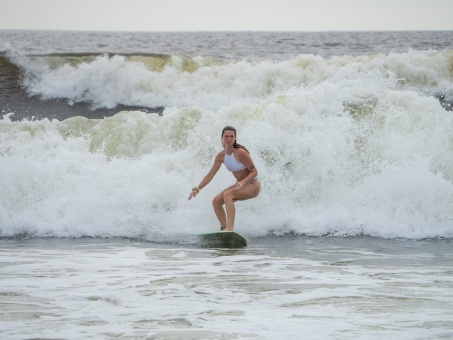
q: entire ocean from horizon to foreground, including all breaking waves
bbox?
[0,31,453,339]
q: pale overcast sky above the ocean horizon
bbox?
[0,0,453,31]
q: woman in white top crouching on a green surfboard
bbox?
[189,126,261,231]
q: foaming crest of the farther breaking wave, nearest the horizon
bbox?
[15,50,453,110]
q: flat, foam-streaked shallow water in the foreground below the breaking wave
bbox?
[0,236,453,339]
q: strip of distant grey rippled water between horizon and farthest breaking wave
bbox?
[0,31,453,60]
